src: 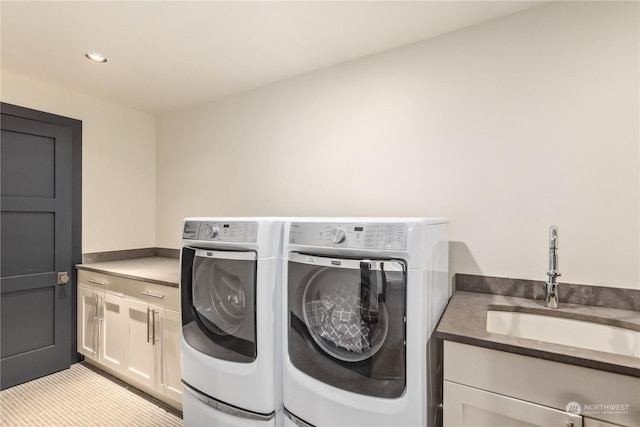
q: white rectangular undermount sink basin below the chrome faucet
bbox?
[487,310,640,358]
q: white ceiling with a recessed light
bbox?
[0,0,545,114]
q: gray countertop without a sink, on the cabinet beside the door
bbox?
[76,256,180,288]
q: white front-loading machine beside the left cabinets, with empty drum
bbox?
[180,218,283,427]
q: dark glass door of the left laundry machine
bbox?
[181,248,257,362]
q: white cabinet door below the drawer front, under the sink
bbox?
[443,381,582,427]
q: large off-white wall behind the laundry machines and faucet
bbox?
[157,2,640,288]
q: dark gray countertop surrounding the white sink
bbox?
[436,291,640,377]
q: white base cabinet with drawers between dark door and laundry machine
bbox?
[78,270,182,409]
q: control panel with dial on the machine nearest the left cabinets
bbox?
[182,221,258,243]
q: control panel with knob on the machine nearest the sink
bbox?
[289,222,407,251]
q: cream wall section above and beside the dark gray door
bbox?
[1,70,156,253]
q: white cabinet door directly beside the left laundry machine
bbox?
[156,309,182,402]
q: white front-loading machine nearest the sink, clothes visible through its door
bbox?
[282,218,449,426]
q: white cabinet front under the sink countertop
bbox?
[443,341,640,427]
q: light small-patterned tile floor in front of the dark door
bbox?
[0,362,182,427]
